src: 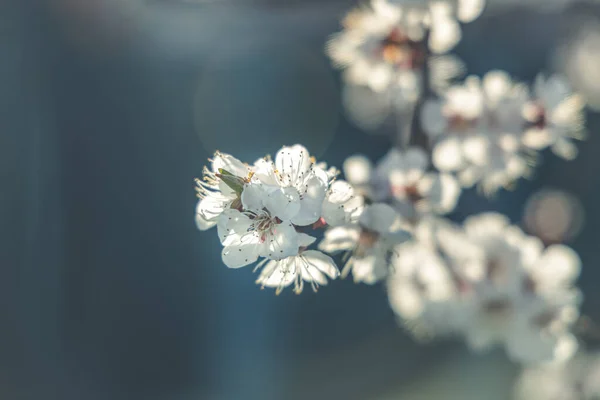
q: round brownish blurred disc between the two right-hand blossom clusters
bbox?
[523,189,584,243]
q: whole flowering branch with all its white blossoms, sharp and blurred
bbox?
[196,0,597,388]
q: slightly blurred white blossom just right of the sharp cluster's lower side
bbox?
[319,203,407,284]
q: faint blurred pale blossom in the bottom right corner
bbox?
[514,352,600,400]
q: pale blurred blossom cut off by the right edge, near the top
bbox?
[555,17,600,110]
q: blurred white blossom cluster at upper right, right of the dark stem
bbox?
[420,71,584,193]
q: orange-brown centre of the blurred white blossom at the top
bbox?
[379,28,424,69]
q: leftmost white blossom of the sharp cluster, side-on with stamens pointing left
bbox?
[196,152,252,231]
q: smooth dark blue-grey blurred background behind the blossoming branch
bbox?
[0,0,600,400]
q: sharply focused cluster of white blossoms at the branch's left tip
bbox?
[196,145,412,293]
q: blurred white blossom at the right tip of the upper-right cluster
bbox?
[523,75,585,160]
